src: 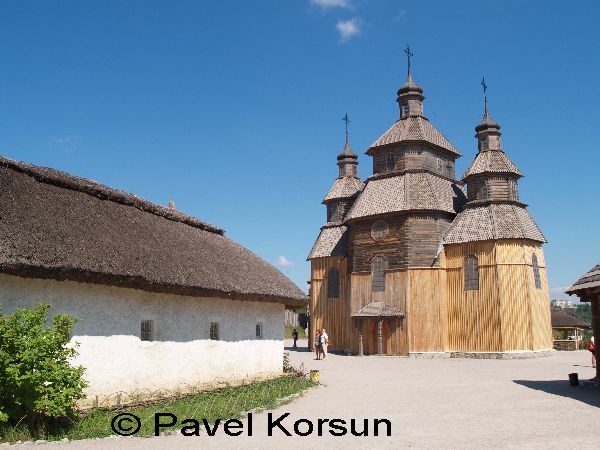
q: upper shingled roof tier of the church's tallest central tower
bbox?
[367,116,460,156]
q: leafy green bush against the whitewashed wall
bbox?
[0,303,87,426]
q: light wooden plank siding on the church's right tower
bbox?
[444,240,552,352]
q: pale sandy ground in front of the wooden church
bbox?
[12,342,600,449]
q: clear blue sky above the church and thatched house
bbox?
[0,0,600,297]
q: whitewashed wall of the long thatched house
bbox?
[0,274,284,398]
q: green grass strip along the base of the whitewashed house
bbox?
[0,375,315,443]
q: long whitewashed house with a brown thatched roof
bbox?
[0,158,306,398]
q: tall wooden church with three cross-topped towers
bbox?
[308,58,552,358]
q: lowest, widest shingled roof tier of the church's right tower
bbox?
[443,203,546,244]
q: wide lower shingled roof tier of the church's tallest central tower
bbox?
[346,172,466,220]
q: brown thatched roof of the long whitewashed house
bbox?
[0,157,306,306]
